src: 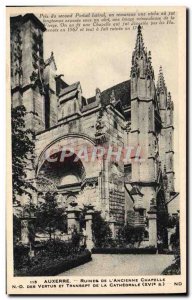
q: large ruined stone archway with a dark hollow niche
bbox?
[36,135,101,210]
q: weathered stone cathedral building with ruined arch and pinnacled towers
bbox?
[11,14,177,246]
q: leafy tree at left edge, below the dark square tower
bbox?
[11,105,35,202]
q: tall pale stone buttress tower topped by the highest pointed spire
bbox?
[131,25,158,246]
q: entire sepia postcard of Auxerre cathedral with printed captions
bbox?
[7,7,186,294]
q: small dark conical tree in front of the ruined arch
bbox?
[35,192,67,240]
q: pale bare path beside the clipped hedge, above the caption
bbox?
[59,254,174,276]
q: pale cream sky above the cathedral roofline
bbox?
[39,12,179,190]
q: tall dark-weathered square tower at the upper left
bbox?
[11,14,46,132]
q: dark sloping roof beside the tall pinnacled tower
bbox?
[87,80,131,109]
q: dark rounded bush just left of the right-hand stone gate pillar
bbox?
[118,224,145,246]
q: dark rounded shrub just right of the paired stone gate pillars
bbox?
[92,213,112,247]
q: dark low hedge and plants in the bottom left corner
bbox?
[14,239,90,276]
